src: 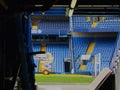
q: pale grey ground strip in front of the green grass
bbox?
[37,83,89,90]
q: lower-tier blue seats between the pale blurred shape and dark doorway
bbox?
[47,44,69,73]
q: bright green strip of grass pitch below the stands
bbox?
[35,74,94,83]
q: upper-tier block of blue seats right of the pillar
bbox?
[72,16,120,32]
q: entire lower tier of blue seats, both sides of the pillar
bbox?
[33,37,116,73]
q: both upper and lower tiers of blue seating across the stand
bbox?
[32,15,120,74]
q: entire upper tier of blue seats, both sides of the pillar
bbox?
[32,15,120,35]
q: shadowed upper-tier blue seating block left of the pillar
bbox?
[32,16,70,35]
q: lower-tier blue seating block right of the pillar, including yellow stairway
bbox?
[74,38,116,75]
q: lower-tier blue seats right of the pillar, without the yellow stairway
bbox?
[73,37,115,73]
